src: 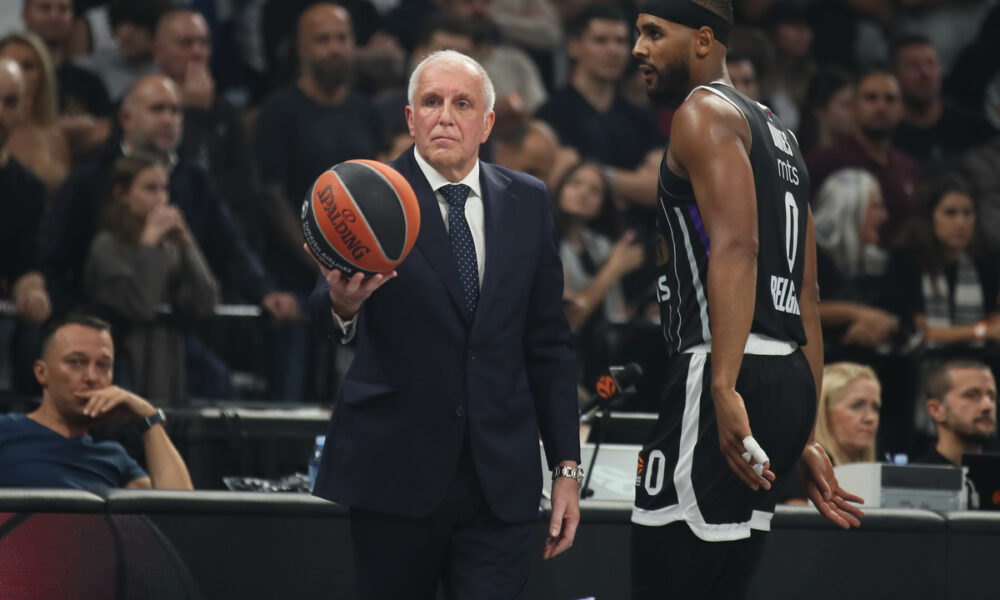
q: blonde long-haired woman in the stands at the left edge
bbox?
[0,33,72,196]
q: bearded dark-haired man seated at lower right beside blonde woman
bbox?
[912,360,997,466]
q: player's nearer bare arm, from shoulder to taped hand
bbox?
[667,92,774,489]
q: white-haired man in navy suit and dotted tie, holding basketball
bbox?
[309,51,581,600]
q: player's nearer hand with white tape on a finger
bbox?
[712,390,774,491]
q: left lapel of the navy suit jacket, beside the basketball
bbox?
[390,146,469,321]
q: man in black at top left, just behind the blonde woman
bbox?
[21,0,111,117]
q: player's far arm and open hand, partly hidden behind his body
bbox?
[799,211,864,529]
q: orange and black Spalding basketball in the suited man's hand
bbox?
[302,160,420,276]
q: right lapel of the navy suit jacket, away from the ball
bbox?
[476,162,516,321]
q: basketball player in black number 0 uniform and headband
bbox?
[632,0,862,600]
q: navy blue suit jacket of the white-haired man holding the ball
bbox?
[309,148,580,522]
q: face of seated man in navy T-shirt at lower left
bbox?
[35,324,115,423]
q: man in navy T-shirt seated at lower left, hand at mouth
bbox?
[0,316,193,490]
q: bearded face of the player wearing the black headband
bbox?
[632,14,693,101]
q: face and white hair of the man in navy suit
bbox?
[406,60,494,181]
